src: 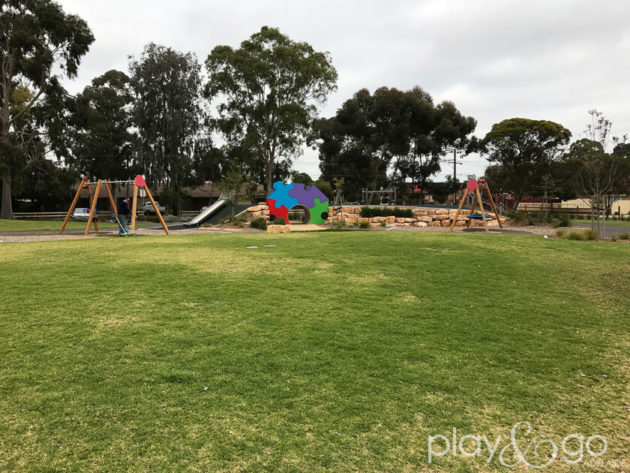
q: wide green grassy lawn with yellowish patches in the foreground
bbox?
[0,232,630,472]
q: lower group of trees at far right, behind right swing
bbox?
[486,110,630,214]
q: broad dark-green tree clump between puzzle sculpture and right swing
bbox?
[315,87,476,199]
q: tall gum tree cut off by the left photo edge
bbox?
[0,0,94,219]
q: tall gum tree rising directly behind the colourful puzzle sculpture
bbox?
[205,26,337,192]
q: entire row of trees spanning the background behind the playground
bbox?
[0,0,630,218]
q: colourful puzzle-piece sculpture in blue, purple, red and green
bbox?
[267,181,328,224]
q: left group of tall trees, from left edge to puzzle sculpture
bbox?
[0,0,337,218]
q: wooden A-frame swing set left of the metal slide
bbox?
[59,174,170,236]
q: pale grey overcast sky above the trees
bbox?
[60,0,630,179]
